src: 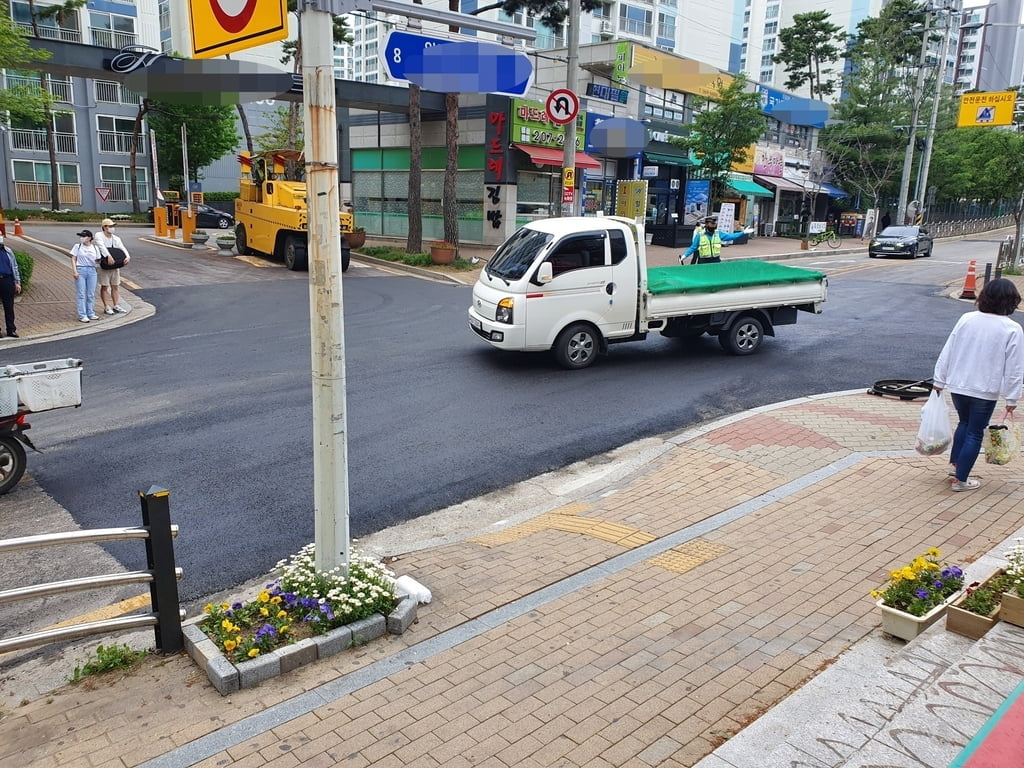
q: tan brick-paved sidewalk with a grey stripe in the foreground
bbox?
[0,392,1024,768]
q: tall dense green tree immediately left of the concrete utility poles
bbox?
[818,0,924,205]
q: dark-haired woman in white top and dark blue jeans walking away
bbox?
[933,278,1024,490]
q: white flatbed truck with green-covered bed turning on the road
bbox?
[469,216,827,369]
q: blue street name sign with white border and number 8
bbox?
[380,31,534,96]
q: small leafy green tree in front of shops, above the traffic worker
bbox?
[671,74,767,210]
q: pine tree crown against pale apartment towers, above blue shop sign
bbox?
[772,10,844,98]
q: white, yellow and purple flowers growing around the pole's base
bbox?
[199,544,395,662]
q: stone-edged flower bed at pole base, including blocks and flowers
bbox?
[184,544,417,695]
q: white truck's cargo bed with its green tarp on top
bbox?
[647,259,827,321]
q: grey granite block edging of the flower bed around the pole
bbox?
[181,597,417,696]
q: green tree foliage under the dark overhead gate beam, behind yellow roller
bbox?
[148,101,239,189]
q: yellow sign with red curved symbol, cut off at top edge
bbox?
[188,0,288,58]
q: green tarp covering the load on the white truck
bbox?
[647,259,825,296]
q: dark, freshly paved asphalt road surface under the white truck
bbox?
[4,232,994,600]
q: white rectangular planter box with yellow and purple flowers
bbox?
[871,549,964,640]
